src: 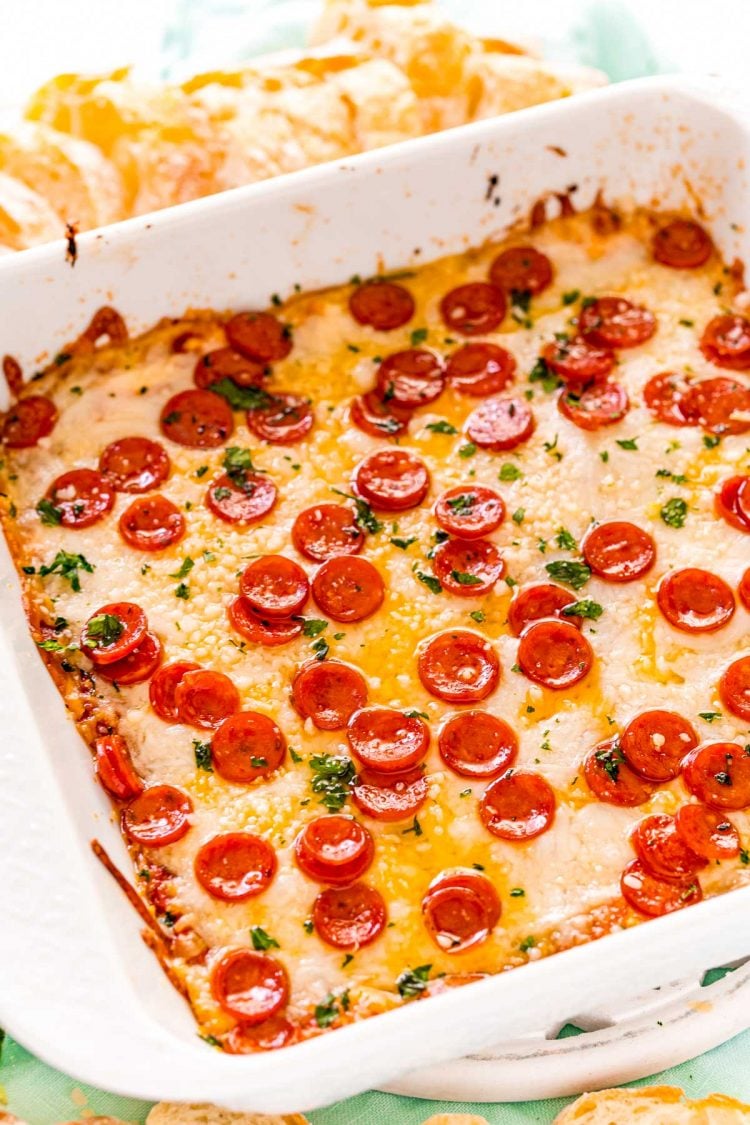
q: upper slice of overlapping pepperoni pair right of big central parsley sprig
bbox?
[346,707,430,774]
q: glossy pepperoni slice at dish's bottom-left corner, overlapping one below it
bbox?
[211,950,289,1025]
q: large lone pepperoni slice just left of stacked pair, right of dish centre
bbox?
[417,629,500,703]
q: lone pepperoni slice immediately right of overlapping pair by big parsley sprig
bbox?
[437,711,518,777]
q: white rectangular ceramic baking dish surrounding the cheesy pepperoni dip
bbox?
[0,80,750,1112]
